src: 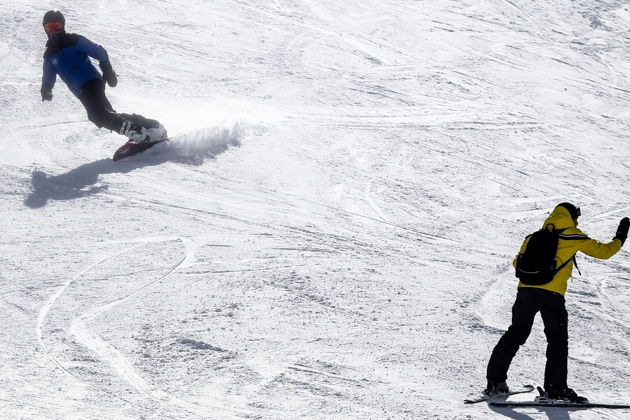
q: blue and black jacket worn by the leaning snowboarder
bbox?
[42,34,109,96]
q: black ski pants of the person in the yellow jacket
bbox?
[487,287,569,388]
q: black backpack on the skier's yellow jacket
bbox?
[516,224,573,286]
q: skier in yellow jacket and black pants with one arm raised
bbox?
[484,203,630,402]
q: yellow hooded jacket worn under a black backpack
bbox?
[512,206,621,296]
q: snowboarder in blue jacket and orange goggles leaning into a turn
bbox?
[41,10,166,151]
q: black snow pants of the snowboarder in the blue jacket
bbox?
[79,79,159,134]
